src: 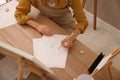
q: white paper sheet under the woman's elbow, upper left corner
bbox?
[0,0,40,29]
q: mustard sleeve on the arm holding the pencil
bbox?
[69,0,88,33]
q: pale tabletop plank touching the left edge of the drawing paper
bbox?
[0,25,33,55]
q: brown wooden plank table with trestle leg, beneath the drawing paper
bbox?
[0,15,119,80]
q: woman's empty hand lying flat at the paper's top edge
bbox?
[36,25,54,36]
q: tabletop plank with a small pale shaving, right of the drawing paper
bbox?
[70,40,97,66]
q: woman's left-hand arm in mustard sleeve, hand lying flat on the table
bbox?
[15,0,53,36]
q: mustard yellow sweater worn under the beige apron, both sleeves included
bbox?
[15,0,88,32]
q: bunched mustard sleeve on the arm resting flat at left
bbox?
[14,0,31,24]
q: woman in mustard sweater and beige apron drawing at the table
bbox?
[15,0,88,48]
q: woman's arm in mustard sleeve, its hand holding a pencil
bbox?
[62,0,88,48]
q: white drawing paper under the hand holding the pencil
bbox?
[33,35,68,68]
